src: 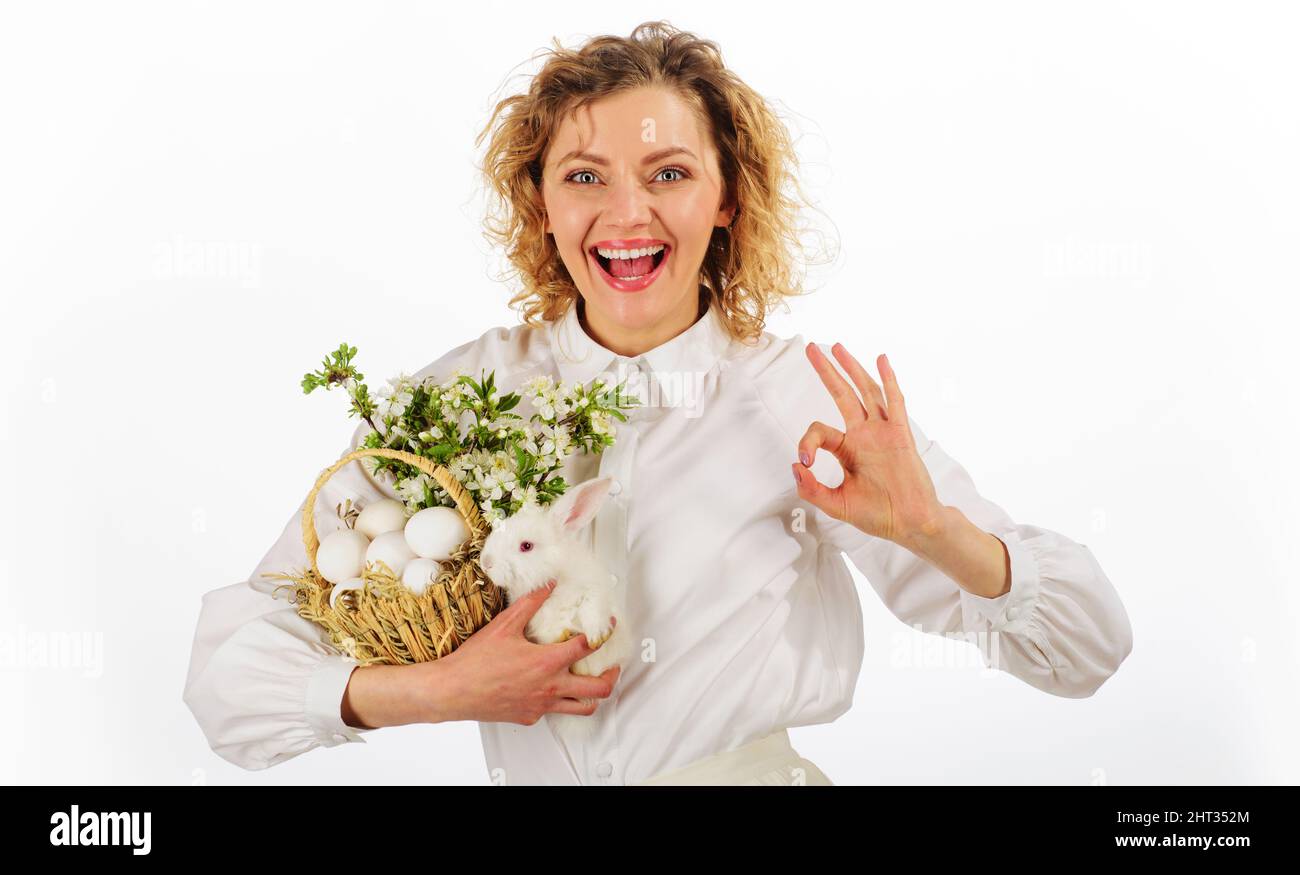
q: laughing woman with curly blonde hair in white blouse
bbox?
[185,22,1132,784]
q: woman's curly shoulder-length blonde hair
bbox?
[475,21,832,341]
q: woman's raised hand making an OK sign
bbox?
[792,343,944,546]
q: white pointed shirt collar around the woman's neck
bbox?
[550,300,731,385]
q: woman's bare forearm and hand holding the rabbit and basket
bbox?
[342,581,620,728]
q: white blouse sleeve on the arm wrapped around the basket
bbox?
[183,423,394,770]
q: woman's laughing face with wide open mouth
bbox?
[542,87,735,355]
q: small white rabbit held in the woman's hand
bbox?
[478,477,632,741]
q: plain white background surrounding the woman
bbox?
[0,3,1300,784]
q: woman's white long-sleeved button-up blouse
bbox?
[185,296,1132,784]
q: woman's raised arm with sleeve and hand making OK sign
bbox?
[793,343,1132,697]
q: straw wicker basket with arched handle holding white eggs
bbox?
[263,449,506,666]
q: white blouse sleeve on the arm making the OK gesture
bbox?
[814,417,1132,698]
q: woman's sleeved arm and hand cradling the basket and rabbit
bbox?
[183,429,619,770]
